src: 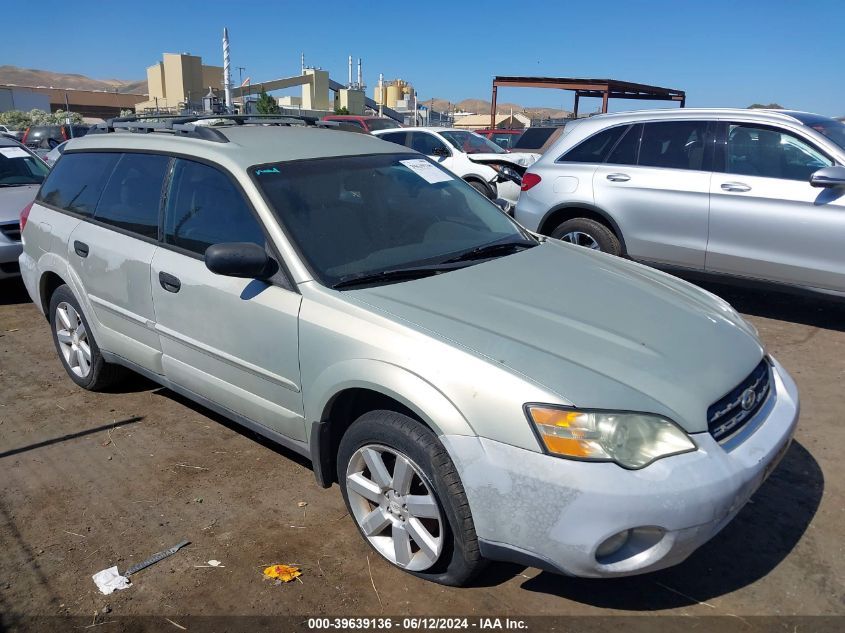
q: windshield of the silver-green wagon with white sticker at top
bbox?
[250,154,534,286]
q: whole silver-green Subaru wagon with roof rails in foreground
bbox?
[20,116,798,584]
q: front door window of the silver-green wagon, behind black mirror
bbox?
[164,159,266,255]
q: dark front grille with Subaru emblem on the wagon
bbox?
[707,358,772,442]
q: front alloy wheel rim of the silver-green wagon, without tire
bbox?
[345,444,445,571]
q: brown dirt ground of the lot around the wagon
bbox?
[0,283,845,631]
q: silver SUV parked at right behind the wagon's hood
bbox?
[516,109,845,296]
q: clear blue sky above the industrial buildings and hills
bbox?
[0,0,845,116]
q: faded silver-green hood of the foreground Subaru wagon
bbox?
[344,240,764,433]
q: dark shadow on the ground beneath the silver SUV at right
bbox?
[679,275,845,332]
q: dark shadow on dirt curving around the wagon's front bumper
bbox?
[522,442,824,611]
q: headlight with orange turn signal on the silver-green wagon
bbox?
[525,404,695,469]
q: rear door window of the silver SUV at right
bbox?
[638,121,707,170]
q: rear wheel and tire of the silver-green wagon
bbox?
[50,284,128,391]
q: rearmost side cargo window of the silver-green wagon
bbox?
[38,152,120,217]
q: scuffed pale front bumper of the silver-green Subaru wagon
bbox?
[441,362,799,577]
